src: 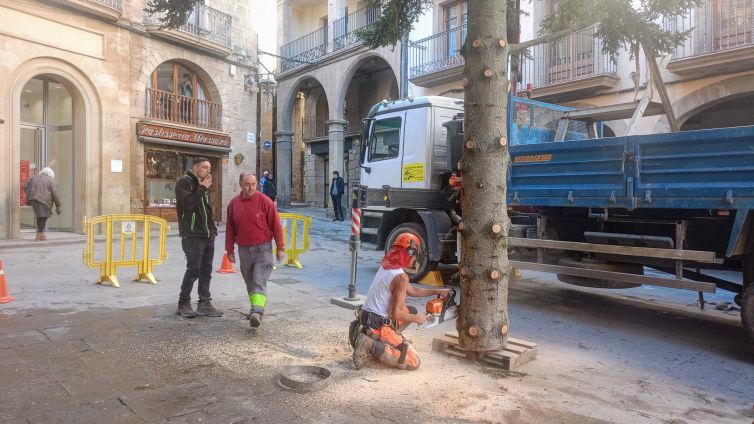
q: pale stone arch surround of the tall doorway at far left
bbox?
[0,57,102,238]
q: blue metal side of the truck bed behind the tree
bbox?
[508,122,754,256]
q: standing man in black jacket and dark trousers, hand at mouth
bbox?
[175,157,223,318]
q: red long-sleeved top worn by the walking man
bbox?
[225,193,285,254]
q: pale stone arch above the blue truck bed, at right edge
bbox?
[653,74,754,133]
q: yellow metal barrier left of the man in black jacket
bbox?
[84,214,168,287]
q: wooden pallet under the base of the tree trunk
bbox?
[432,332,537,371]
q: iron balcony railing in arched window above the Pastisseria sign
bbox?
[144,88,223,130]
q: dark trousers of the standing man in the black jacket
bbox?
[179,237,215,303]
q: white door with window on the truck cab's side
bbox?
[361,111,406,188]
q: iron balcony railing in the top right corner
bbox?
[662,0,754,59]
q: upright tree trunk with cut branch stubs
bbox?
[456,0,510,352]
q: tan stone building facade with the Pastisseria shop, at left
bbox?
[0,0,259,238]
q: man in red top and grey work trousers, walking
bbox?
[225,171,285,328]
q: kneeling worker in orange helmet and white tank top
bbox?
[349,233,449,370]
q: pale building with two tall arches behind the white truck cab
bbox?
[275,0,403,207]
